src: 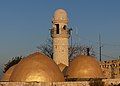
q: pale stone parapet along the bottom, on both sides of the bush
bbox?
[0,79,120,86]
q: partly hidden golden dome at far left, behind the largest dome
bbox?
[1,65,16,81]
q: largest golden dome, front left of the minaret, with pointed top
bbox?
[10,52,64,82]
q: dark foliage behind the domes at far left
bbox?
[3,56,22,73]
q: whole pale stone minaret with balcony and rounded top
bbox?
[51,9,70,66]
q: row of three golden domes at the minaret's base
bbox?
[2,52,103,82]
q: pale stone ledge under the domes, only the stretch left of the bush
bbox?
[0,82,89,86]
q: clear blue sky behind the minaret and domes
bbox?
[0,0,120,65]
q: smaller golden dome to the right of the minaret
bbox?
[66,55,103,78]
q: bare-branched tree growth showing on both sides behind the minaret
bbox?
[37,39,95,59]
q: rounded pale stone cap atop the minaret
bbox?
[53,9,68,23]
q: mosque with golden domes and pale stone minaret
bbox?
[1,9,119,86]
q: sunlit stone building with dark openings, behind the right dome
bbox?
[100,59,120,79]
